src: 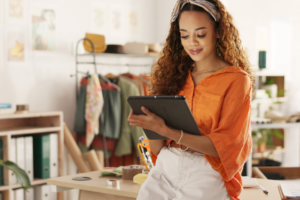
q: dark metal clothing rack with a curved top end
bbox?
[71,38,156,167]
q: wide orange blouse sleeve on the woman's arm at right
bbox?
[206,75,252,181]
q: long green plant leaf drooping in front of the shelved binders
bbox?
[0,160,31,190]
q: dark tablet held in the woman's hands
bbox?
[127,96,201,140]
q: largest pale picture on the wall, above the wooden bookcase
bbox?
[31,6,57,51]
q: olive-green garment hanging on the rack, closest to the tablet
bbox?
[115,76,145,157]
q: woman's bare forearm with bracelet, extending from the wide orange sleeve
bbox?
[163,126,219,157]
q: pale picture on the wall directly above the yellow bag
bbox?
[91,2,108,35]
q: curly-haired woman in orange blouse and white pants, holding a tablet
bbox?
[128,0,254,200]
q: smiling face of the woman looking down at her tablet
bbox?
[179,11,217,62]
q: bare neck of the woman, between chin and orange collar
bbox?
[195,51,224,71]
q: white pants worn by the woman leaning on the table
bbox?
[137,147,230,200]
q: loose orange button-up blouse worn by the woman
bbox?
[151,66,252,200]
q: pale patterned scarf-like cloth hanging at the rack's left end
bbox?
[85,74,104,147]
